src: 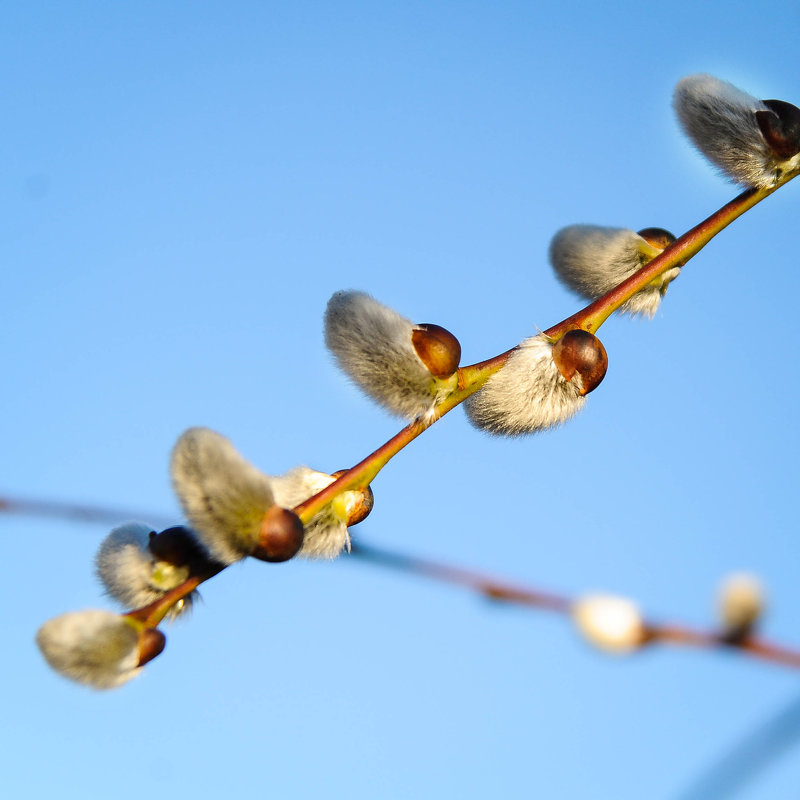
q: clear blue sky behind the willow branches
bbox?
[0,0,800,800]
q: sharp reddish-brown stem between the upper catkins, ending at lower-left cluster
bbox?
[294,180,797,523]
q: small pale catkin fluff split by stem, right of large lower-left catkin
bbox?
[271,467,355,558]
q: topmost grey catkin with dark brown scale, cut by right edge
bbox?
[673,75,800,187]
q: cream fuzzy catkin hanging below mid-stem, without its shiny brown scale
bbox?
[464,333,586,436]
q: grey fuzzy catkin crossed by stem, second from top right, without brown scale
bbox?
[550,225,680,317]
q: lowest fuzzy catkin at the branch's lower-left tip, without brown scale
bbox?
[36,609,141,689]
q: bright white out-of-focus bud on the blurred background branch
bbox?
[572,594,647,654]
